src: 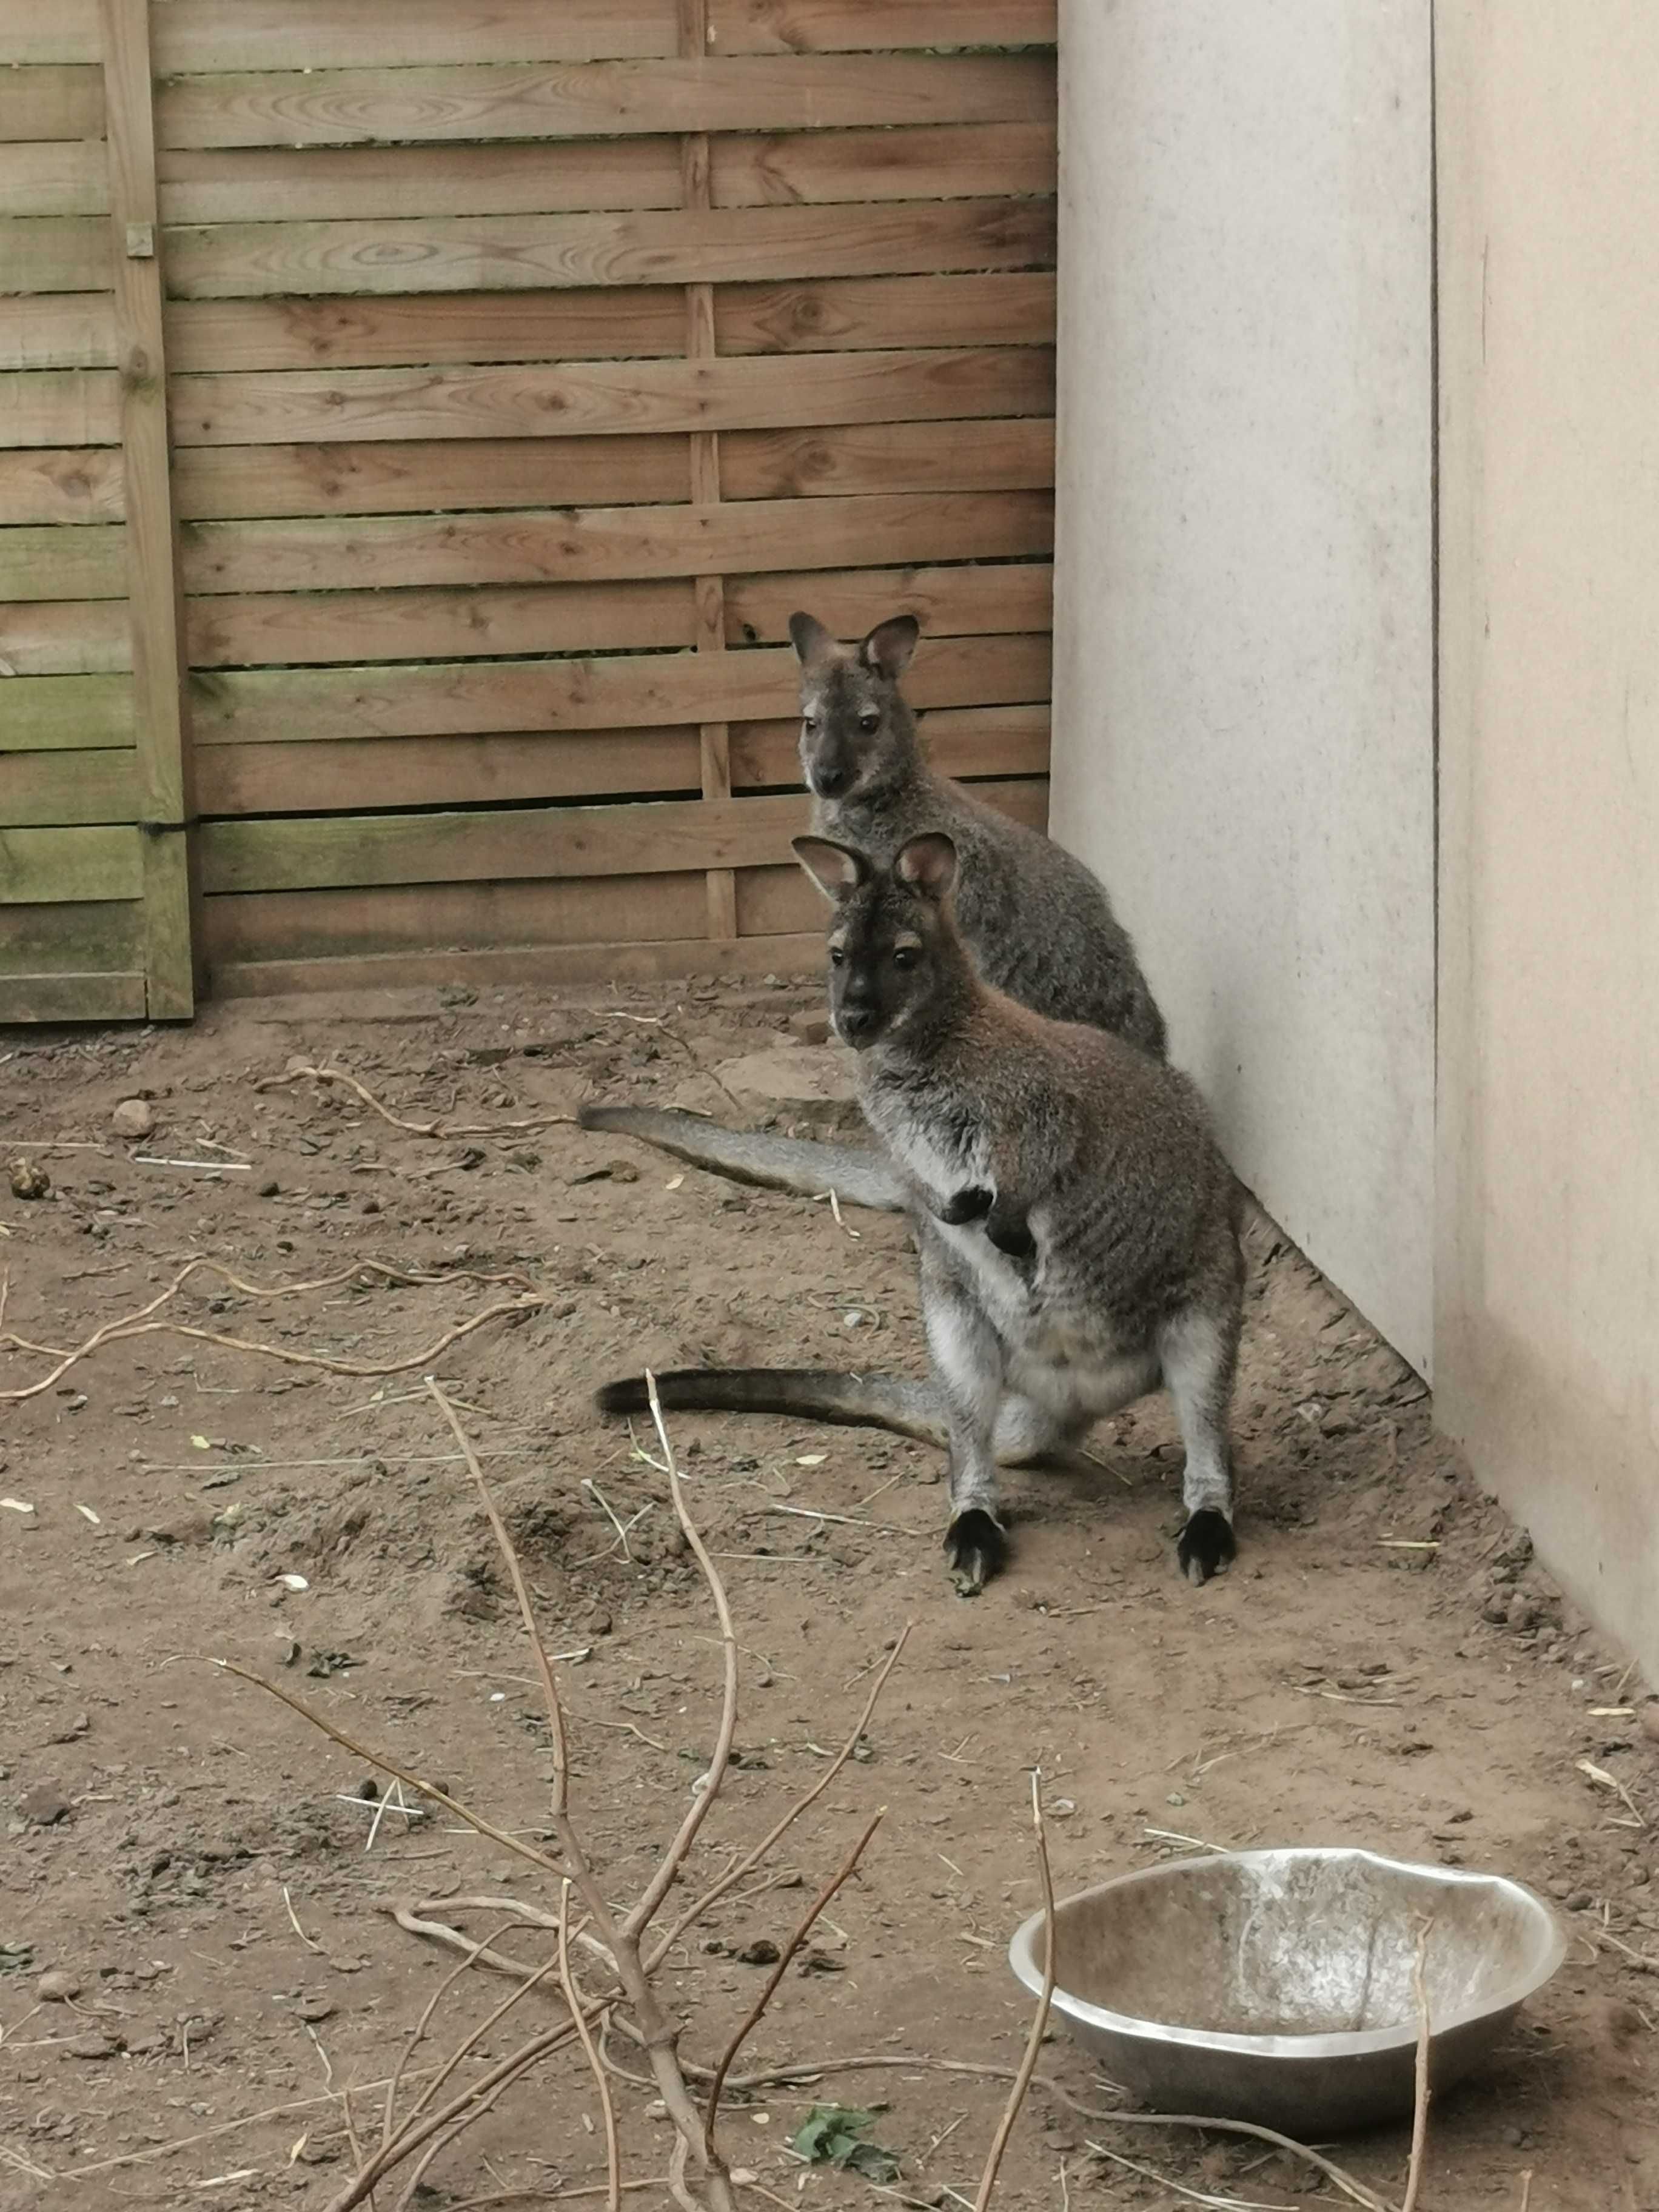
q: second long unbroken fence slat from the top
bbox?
[166,199,1055,298]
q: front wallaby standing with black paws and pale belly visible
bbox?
[600,832,1243,1595]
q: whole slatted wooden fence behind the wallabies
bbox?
[0,0,1055,1020]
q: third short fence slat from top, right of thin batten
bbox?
[714,270,1055,354]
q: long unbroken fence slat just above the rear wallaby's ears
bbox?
[181,491,1053,593]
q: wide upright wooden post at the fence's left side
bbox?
[98,0,195,1020]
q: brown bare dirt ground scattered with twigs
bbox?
[0,982,1659,2212]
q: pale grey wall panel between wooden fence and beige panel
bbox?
[1053,0,1433,1372]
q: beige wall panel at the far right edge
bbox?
[1436,0,1659,1681]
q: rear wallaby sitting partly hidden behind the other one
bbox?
[580,615,1164,1212]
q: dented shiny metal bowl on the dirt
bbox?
[1008,1849,1566,2139]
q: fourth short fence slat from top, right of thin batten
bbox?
[721,416,1055,500]
